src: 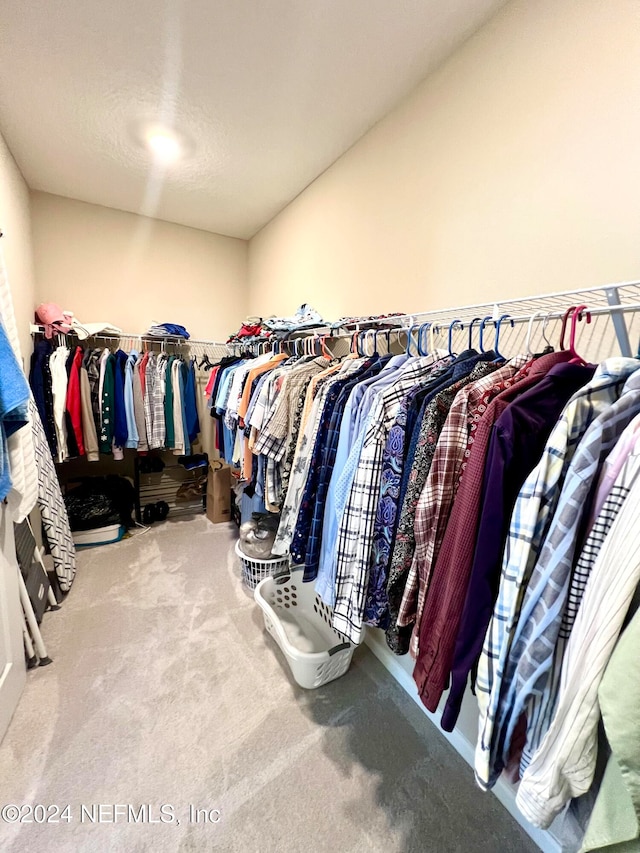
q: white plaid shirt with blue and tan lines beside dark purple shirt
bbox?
[475,358,637,788]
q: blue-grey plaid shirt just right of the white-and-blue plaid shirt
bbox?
[502,370,640,770]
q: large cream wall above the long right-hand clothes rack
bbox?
[249,0,640,319]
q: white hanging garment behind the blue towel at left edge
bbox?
[0,242,38,523]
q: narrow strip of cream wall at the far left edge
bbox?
[0,129,36,362]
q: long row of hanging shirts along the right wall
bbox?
[218,305,640,844]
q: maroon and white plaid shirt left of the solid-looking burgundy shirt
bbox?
[398,356,526,644]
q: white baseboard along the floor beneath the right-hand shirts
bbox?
[365,630,562,853]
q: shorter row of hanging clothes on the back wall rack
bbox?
[29,335,200,462]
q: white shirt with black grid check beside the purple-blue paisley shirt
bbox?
[333,358,440,643]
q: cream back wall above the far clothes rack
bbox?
[32,192,247,340]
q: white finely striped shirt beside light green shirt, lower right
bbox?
[516,470,640,828]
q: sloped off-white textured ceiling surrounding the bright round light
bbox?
[0,0,504,238]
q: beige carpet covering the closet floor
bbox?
[0,517,537,853]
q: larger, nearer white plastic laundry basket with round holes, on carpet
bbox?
[254,569,355,688]
